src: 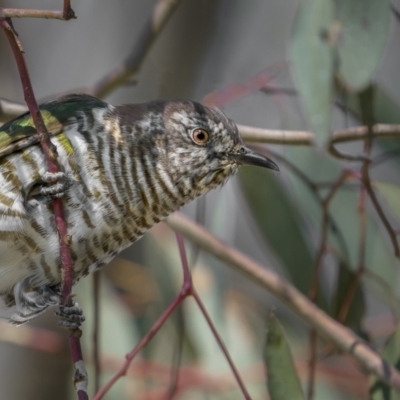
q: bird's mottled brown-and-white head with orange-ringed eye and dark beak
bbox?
[156,101,279,195]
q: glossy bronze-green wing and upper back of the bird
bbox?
[0,94,107,159]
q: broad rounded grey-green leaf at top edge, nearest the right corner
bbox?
[336,0,390,91]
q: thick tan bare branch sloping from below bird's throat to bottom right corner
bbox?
[166,213,400,391]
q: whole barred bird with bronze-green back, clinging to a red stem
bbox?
[0,94,279,328]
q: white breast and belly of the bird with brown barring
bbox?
[0,106,183,295]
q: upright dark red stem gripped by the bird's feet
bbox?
[0,13,88,400]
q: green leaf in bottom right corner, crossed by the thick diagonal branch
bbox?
[369,327,400,400]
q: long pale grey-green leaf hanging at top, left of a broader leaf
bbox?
[290,0,334,143]
